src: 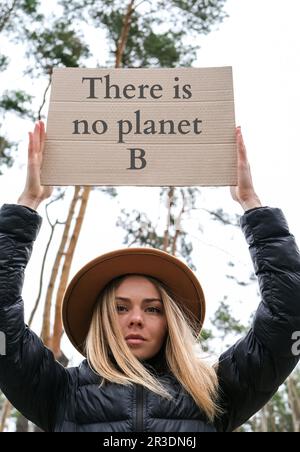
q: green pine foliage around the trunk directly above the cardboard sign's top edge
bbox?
[60,0,226,67]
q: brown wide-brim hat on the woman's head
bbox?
[62,247,205,356]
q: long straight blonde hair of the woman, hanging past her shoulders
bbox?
[86,275,220,421]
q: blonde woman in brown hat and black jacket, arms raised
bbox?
[0,121,300,432]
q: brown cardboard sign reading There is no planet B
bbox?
[41,67,237,186]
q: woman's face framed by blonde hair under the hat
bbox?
[116,275,167,360]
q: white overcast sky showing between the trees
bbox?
[0,0,300,363]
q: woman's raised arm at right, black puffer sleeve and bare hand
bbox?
[217,129,300,431]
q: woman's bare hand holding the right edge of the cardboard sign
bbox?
[230,127,262,210]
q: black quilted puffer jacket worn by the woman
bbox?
[0,204,300,432]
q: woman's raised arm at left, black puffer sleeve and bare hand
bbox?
[0,122,68,431]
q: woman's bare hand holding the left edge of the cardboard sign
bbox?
[18,121,53,209]
